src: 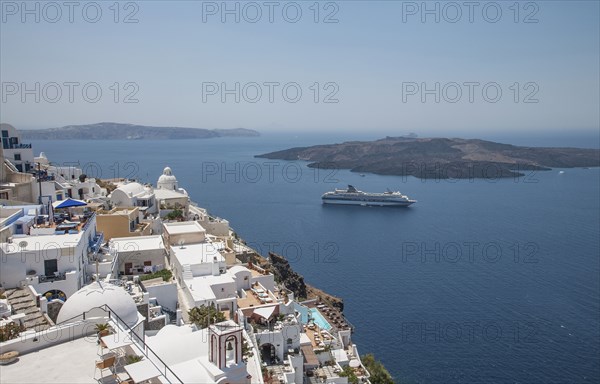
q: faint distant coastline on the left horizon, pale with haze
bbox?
[20,123,260,140]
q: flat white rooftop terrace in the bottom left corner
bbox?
[0,338,100,384]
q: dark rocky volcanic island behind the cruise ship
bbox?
[255,136,600,179]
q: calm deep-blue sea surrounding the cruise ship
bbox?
[33,136,600,383]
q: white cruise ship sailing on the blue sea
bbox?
[321,185,417,207]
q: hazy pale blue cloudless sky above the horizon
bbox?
[0,1,600,136]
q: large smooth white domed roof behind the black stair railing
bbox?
[56,282,138,327]
